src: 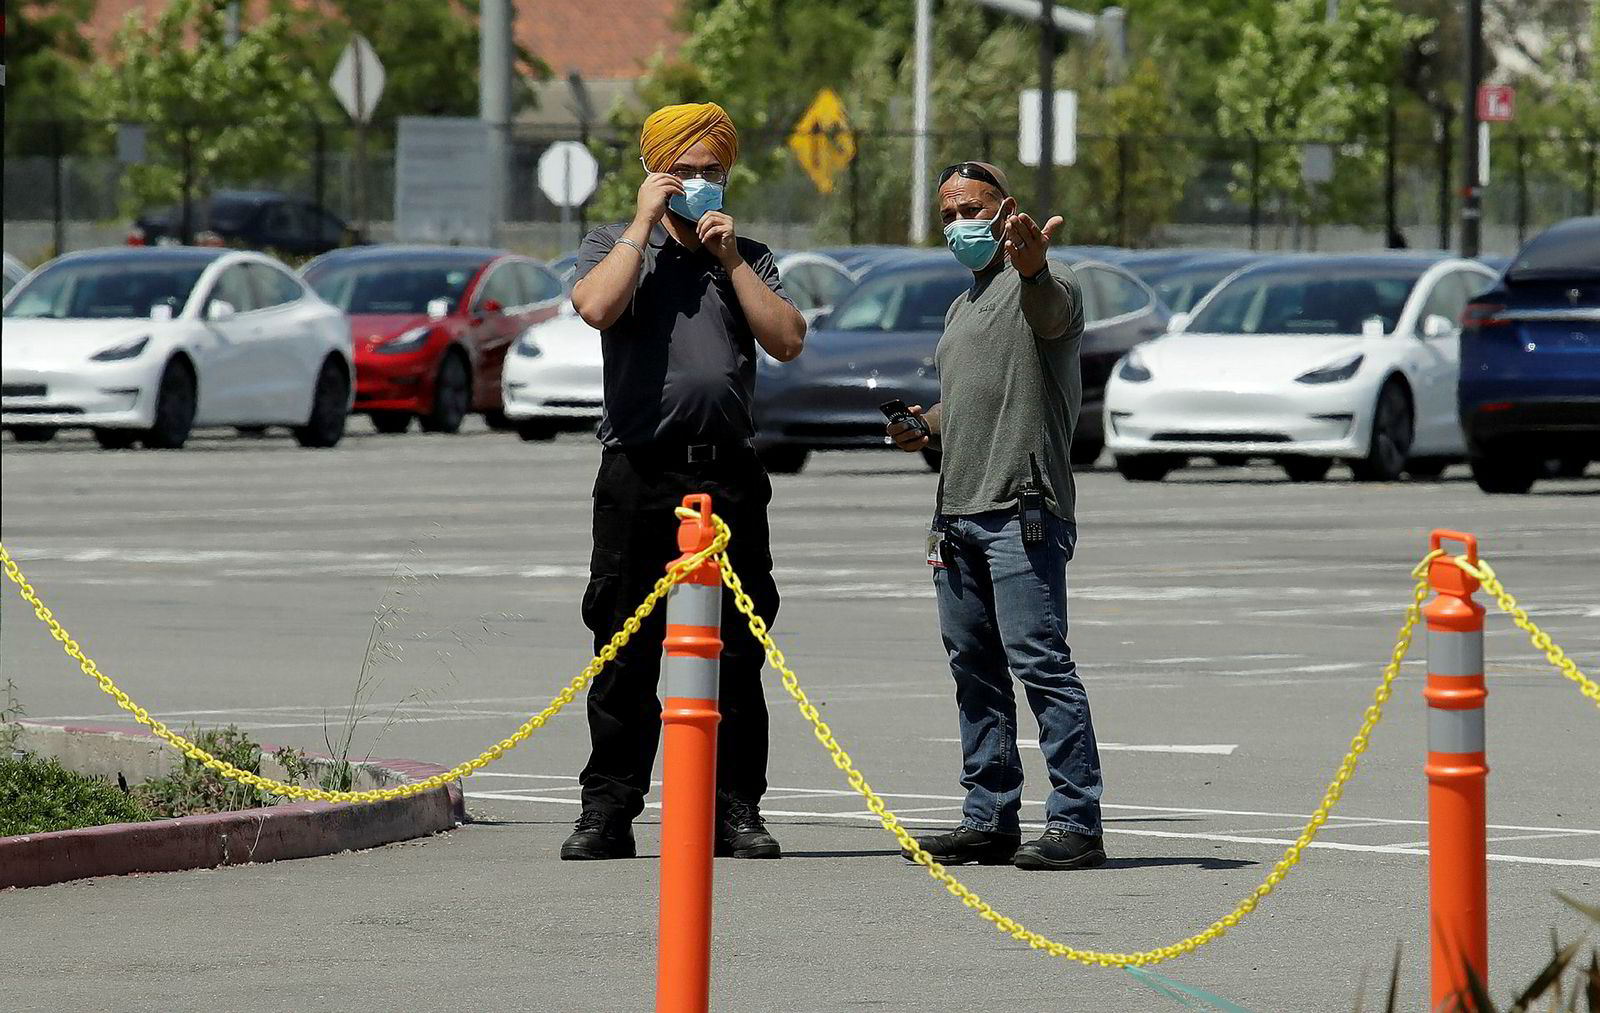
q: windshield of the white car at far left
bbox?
[5,256,210,320]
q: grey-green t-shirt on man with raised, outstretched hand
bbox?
[934,261,1083,520]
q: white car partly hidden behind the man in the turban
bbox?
[501,253,856,440]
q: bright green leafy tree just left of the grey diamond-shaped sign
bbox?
[94,0,326,219]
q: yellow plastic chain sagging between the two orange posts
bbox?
[712,517,1438,967]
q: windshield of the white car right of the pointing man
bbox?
[1184,262,1424,334]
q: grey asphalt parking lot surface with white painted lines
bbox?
[0,422,1600,1011]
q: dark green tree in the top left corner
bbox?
[5,0,94,155]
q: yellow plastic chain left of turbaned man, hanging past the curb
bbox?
[0,525,730,802]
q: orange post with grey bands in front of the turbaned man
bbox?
[656,493,722,1013]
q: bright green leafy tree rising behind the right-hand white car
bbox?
[1218,0,1430,233]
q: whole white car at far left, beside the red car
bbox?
[0,246,352,448]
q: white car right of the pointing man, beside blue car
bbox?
[1106,254,1494,482]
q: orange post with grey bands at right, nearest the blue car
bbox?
[1422,531,1490,1010]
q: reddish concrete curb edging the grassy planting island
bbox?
[0,722,467,888]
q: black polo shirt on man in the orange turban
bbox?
[576,224,789,446]
